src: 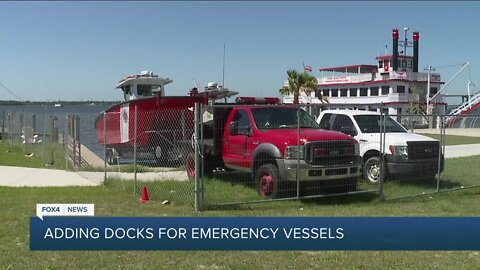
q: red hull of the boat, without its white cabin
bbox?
[95,96,203,159]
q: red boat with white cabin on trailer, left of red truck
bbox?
[95,71,237,165]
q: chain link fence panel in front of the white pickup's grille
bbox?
[378,111,445,199]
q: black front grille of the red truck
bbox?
[304,141,355,165]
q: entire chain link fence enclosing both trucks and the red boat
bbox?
[5,102,480,209]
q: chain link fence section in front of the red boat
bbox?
[101,103,195,205]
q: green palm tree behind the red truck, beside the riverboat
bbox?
[279,69,318,104]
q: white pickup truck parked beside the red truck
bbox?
[317,110,443,183]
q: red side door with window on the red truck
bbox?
[223,110,252,168]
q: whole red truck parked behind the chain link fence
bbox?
[189,97,362,198]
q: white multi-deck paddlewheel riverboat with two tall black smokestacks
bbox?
[284,28,446,126]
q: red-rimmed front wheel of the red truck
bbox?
[255,164,280,199]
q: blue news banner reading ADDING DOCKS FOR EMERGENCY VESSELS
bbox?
[30,208,480,250]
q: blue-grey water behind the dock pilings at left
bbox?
[0,104,111,157]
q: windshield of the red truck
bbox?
[252,107,320,130]
